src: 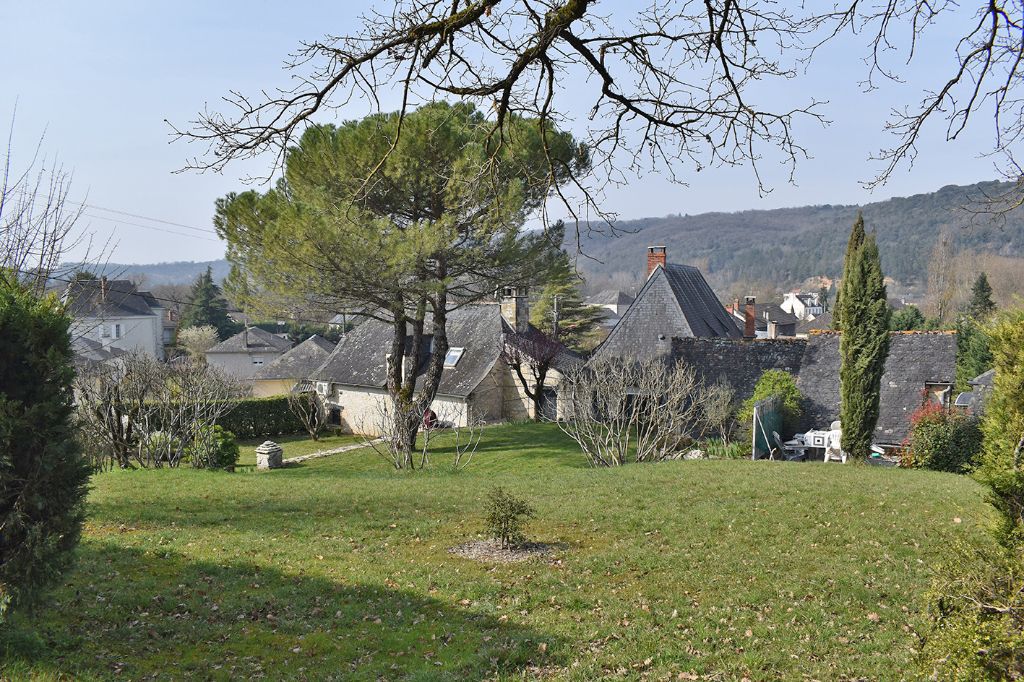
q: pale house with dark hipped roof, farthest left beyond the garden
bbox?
[62,278,165,359]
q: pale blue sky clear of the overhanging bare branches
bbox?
[0,0,996,263]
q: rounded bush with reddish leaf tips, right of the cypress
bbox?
[907,402,981,473]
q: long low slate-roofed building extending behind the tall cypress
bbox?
[673,332,956,446]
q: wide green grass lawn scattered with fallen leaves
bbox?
[0,425,993,680]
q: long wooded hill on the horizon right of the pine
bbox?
[580,182,1024,289]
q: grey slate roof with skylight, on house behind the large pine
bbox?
[310,303,508,397]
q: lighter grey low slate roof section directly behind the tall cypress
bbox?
[797,332,956,443]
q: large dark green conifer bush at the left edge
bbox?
[0,272,90,623]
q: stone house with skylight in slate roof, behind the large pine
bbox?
[310,290,574,434]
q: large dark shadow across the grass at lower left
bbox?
[8,543,565,680]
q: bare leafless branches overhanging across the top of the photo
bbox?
[180,0,1024,223]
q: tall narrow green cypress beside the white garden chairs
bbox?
[836,225,892,458]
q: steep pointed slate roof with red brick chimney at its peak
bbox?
[594,263,742,358]
